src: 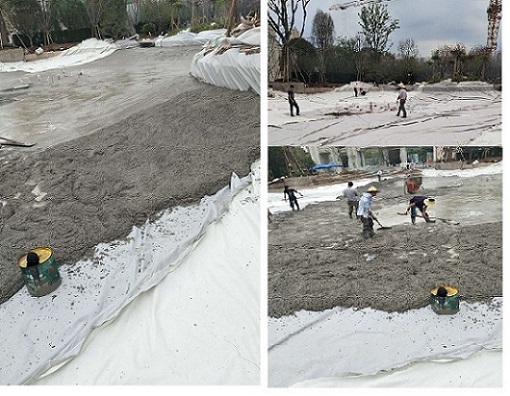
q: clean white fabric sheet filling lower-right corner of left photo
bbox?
[33,160,260,385]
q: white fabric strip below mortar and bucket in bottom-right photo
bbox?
[268,298,503,387]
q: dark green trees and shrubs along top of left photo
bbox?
[0,0,260,47]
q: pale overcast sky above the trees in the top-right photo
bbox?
[296,0,501,57]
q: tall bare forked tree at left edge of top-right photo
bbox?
[268,0,311,81]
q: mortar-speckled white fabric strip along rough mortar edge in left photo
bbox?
[0,169,255,384]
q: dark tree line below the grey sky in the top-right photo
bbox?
[270,0,502,84]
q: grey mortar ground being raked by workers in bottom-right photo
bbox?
[268,175,503,317]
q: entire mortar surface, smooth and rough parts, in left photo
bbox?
[0,48,260,303]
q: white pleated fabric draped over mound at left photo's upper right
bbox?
[191,28,260,95]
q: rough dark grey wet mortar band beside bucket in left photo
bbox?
[0,84,260,303]
